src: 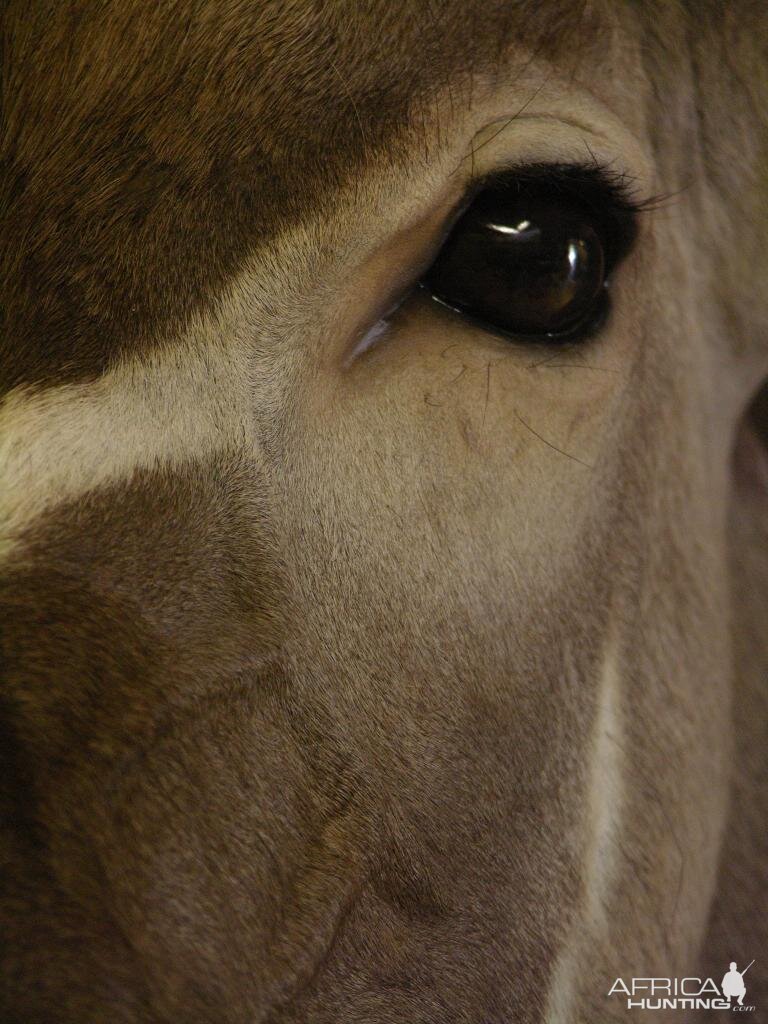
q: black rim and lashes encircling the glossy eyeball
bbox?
[420,161,658,348]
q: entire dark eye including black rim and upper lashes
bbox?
[423,169,631,342]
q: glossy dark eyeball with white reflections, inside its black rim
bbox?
[425,188,605,335]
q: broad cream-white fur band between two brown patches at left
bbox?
[0,319,250,556]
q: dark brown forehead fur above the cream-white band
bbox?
[0,0,583,388]
